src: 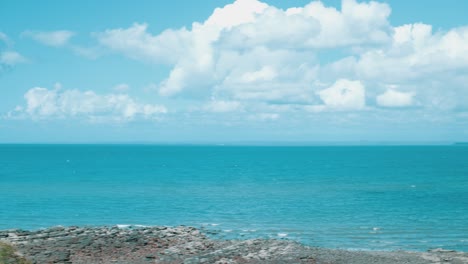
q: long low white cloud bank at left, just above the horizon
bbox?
[10,87,167,121]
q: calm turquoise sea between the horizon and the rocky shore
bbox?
[0,145,468,251]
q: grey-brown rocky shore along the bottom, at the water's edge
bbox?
[0,226,468,264]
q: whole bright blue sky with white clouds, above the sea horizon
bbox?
[0,0,468,144]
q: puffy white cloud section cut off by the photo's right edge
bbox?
[355,24,468,82]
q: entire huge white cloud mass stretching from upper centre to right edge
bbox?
[88,0,468,117]
